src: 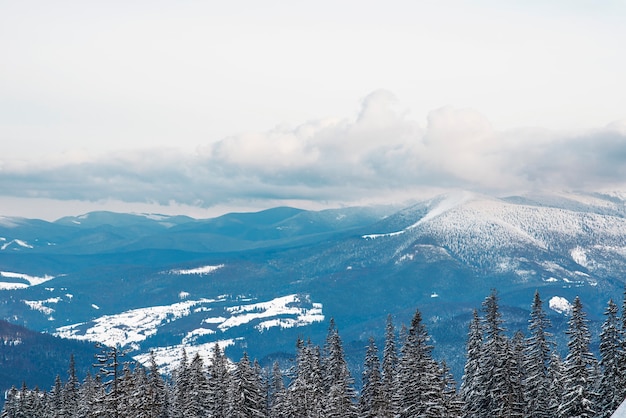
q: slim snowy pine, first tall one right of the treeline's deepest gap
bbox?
[460,309,485,418]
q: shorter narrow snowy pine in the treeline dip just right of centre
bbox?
[359,337,385,418]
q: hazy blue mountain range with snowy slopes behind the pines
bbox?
[0,192,626,384]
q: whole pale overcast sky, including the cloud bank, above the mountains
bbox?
[0,0,626,220]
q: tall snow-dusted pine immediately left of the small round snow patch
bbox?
[524,292,554,418]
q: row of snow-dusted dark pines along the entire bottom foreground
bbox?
[2,291,626,418]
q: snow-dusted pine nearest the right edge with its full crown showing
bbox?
[597,299,624,417]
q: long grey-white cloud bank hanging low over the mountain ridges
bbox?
[0,90,626,211]
